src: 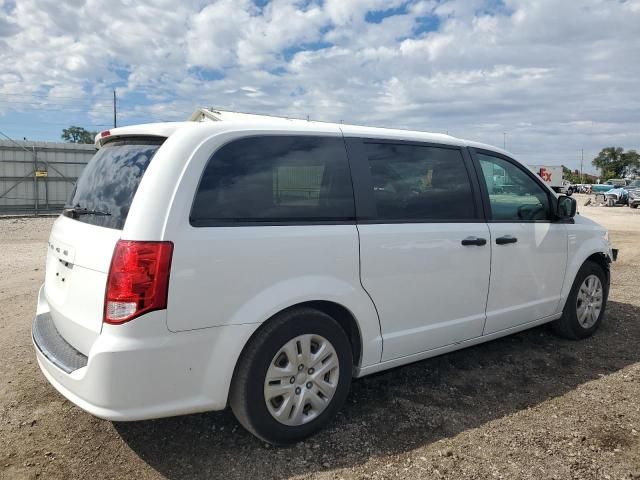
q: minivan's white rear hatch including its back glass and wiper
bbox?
[44,137,165,355]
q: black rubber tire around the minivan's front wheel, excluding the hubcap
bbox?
[551,261,609,340]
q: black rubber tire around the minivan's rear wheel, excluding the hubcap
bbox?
[229,308,353,445]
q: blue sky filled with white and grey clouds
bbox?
[0,0,640,172]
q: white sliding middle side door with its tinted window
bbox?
[348,139,491,361]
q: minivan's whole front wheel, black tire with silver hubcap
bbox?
[552,261,609,340]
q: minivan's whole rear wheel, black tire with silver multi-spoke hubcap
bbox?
[229,308,353,445]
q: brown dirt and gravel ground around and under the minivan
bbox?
[0,196,640,480]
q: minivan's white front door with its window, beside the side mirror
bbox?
[475,151,568,335]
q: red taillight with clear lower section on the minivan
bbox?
[104,240,173,325]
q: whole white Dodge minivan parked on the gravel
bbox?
[32,119,617,444]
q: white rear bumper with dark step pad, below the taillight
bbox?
[32,284,257,421]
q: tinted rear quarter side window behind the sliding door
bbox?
[191,136,355,227]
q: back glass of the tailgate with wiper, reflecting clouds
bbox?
[63,138,165,230]
